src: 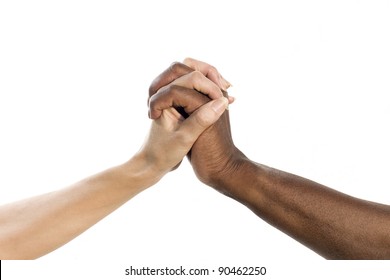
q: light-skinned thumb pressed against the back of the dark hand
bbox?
[180,97,229,141]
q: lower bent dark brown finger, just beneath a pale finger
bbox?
[149,84,210,119]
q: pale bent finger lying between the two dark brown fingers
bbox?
[172,71,223,99]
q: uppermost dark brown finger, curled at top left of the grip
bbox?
[149,62,194,98]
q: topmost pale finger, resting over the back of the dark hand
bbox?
[183,57,231,90]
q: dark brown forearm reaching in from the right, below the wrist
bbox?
[213,154,390,259]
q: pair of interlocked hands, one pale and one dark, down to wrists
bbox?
[140,58,241,191]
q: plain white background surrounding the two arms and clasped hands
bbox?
[0,0,390,279]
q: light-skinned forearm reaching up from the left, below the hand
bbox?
[0,156,163,259]
